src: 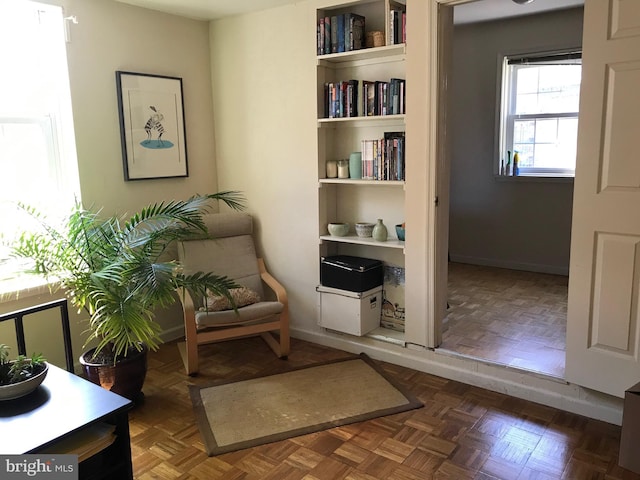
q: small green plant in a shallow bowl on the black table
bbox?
[0,343,49,401]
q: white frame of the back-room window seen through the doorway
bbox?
[493,46,582,181]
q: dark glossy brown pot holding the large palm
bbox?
[80,345,148,401]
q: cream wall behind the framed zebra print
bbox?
[0,0,218,365]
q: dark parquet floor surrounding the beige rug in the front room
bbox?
[130,338,640,480]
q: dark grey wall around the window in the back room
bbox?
[449,8,582,274]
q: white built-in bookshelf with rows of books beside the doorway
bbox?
[316,0,411,335]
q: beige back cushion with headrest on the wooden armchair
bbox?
[178,213,264,299]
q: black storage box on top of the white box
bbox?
[320,255,384,292]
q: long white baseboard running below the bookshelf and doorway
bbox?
[291,328,623,425]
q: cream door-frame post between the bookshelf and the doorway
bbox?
[405,0,452,348]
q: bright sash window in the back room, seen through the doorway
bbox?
[498,52,582,177]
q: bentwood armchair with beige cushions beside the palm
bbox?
[178,212,289,375]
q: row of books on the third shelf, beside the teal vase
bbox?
[362,132,405,180]
